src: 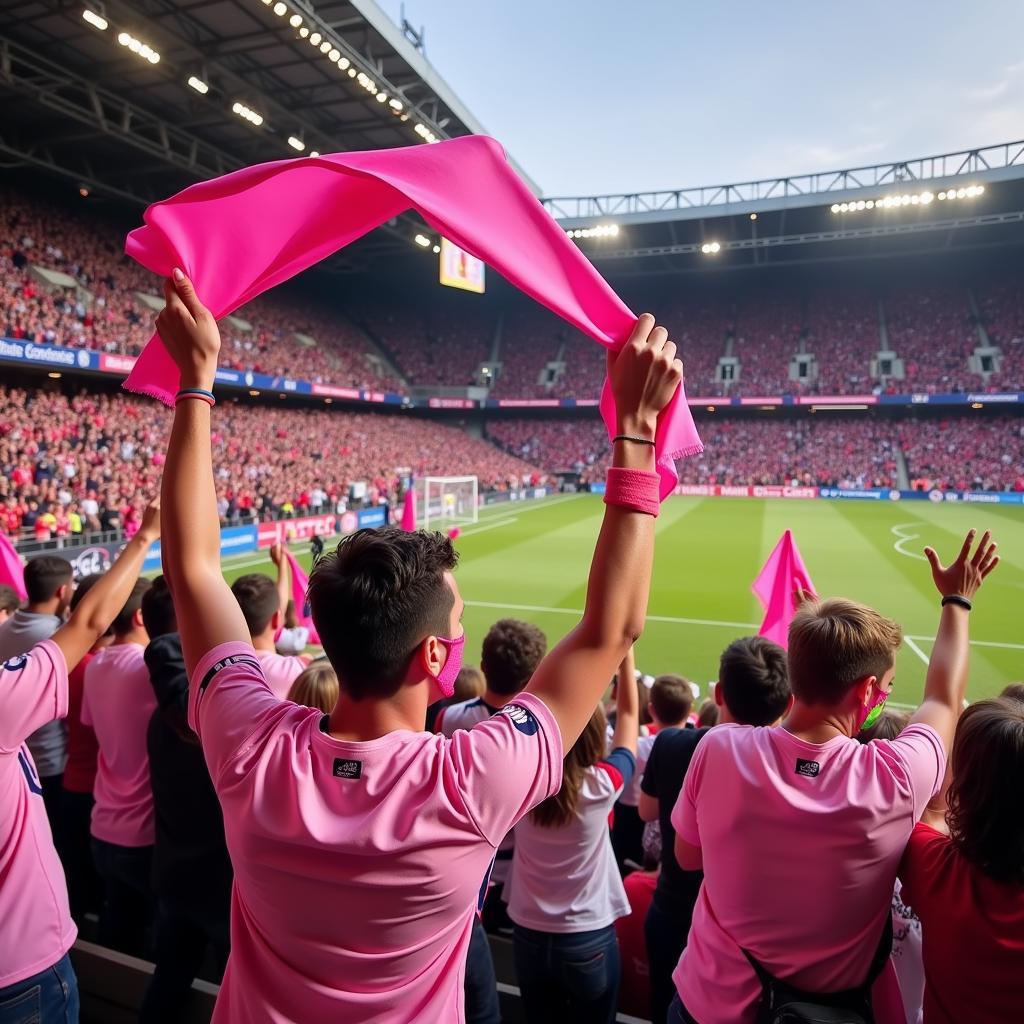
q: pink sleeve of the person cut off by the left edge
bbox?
[0,640,68,754]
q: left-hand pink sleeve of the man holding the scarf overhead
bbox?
[188,641,295,785]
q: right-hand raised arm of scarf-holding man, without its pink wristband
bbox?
[526,313,683,750]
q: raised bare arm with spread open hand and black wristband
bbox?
[910,529,999,752]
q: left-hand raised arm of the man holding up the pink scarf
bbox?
[157,270,249,675]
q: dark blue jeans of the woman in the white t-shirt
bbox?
[512,925,618,1024]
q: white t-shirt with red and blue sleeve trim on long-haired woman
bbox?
[506,749,636,934]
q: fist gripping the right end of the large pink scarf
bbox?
[608,313,683,439]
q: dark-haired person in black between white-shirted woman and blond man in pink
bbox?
[639,637,793,1020]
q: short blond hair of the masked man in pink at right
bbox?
[788,597,903,708]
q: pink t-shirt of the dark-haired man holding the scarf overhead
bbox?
[189,643,562,1024]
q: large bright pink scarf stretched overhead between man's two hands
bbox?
[125,135,703,498]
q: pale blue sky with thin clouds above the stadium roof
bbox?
[378,0,1024,196]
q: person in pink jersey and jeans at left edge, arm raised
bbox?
[0,506,160,1024]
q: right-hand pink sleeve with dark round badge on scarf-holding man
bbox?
[445,693,562,847]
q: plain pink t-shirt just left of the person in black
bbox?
[82,643,157,847]
